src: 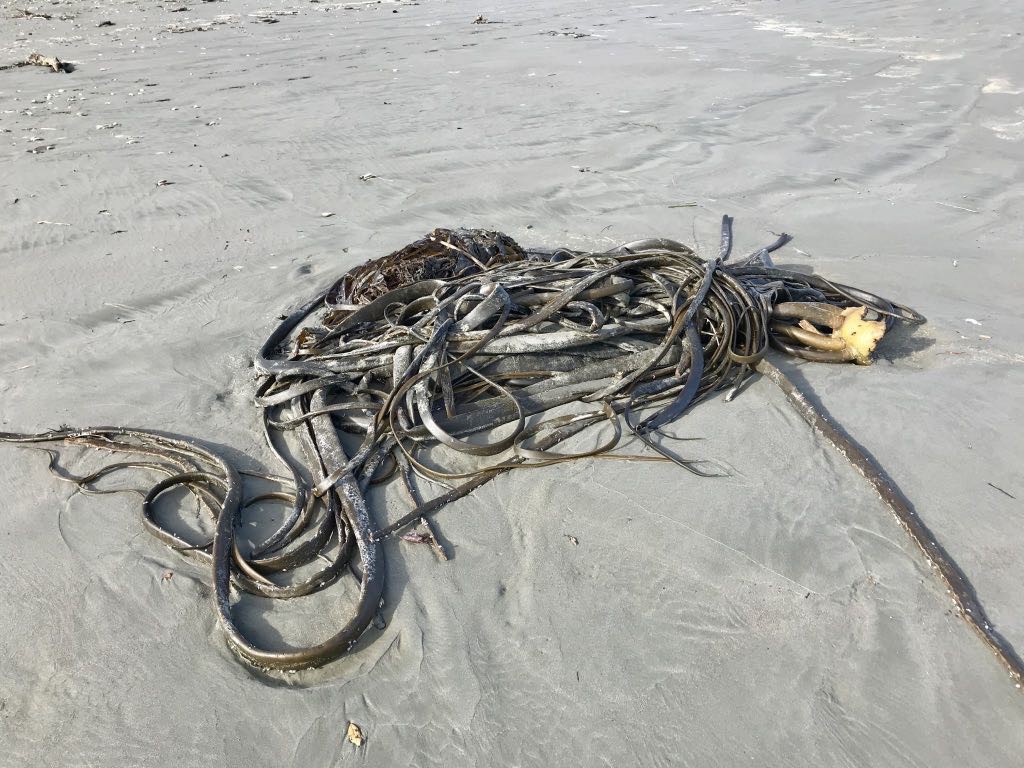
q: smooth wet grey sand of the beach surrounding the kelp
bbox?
[0,0,1024,768]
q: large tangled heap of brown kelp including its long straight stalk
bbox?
[0,217,1024,684]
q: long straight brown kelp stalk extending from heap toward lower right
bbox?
[757,359,1024,688]
